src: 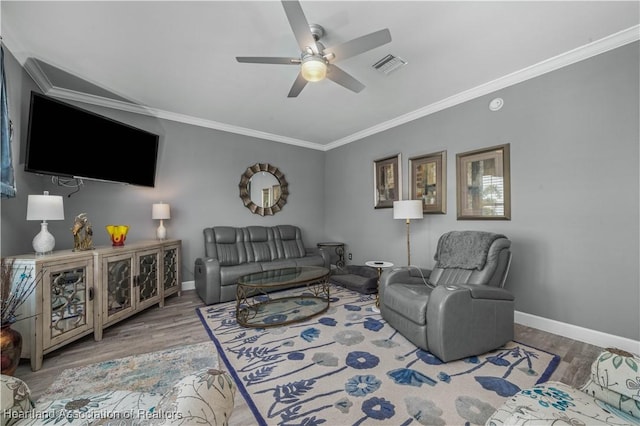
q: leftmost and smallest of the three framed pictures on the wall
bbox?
[373,154,402,209]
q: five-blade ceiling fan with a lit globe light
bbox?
[236,0,391,98]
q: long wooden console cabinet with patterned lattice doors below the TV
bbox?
[11,240,181,371]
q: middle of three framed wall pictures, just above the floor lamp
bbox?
[409,151,447,213]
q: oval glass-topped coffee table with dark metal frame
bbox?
[236,266,331,328]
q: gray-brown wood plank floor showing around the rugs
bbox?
[15,290,602,399]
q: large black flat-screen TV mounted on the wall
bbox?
[24,92,159,186]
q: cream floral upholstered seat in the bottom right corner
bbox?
[486,349,640,426]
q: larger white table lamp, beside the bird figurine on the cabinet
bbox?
[27,191,64,255]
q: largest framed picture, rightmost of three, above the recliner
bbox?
[456,143,511,220]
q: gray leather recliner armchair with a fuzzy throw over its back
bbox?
[380,231,514,362]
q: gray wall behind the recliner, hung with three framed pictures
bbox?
[325,43,640,340]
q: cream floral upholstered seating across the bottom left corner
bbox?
[0,369,236,426]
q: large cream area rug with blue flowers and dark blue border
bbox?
[198,286,559,426]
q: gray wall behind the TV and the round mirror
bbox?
[1,49,325,281]
